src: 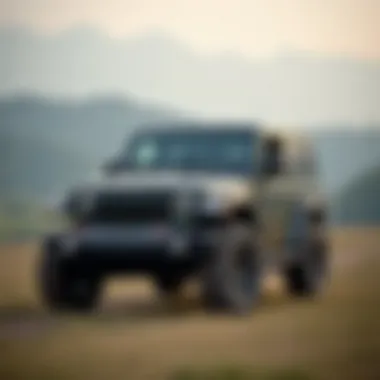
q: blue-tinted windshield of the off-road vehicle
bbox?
[117,131,253,174]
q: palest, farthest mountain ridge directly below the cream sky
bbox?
[0,28,380,124]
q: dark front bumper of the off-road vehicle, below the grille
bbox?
[45,227,215,273]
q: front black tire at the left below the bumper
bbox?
[38,240,100,311]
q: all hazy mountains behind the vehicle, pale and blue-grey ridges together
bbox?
[0,28,380,238]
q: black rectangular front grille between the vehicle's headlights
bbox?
[88,191,173,223]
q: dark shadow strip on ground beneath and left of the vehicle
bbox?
[0,294,297,330]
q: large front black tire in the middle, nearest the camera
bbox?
[202,224,262,314]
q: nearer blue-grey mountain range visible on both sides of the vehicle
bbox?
[0,96,380,224]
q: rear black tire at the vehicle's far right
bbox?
[285,239,328,297]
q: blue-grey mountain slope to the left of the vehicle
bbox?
[0,97,180,202]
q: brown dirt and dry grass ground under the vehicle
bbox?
[0,228,380,380]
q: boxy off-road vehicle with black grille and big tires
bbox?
[39,122,328,313]
